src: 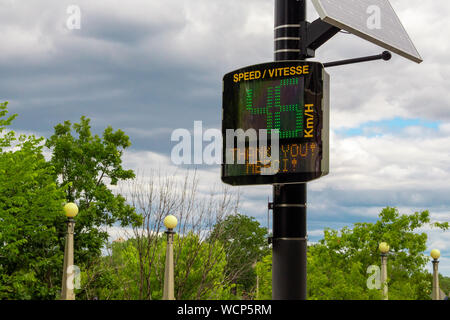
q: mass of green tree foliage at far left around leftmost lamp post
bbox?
[0,103,140,299]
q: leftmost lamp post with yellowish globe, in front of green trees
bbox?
[61,202,78,300]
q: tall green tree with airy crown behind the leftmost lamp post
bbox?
[46,117,141,265]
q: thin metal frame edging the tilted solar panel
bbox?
[312,0,423,63]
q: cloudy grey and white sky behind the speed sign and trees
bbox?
[0,0,450,276]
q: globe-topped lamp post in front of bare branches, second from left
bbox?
[163,215,178,300]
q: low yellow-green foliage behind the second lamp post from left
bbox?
[80,233,232,300]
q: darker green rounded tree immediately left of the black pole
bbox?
[211,214,269,295]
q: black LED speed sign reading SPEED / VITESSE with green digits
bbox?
[222,61,329,185]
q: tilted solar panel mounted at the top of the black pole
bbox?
[312,0,423,63]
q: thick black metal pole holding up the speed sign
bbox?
[272,0,307,300]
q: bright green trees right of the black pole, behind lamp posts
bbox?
[257,207,449,300]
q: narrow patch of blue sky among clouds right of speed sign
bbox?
[336,117,441,137]
